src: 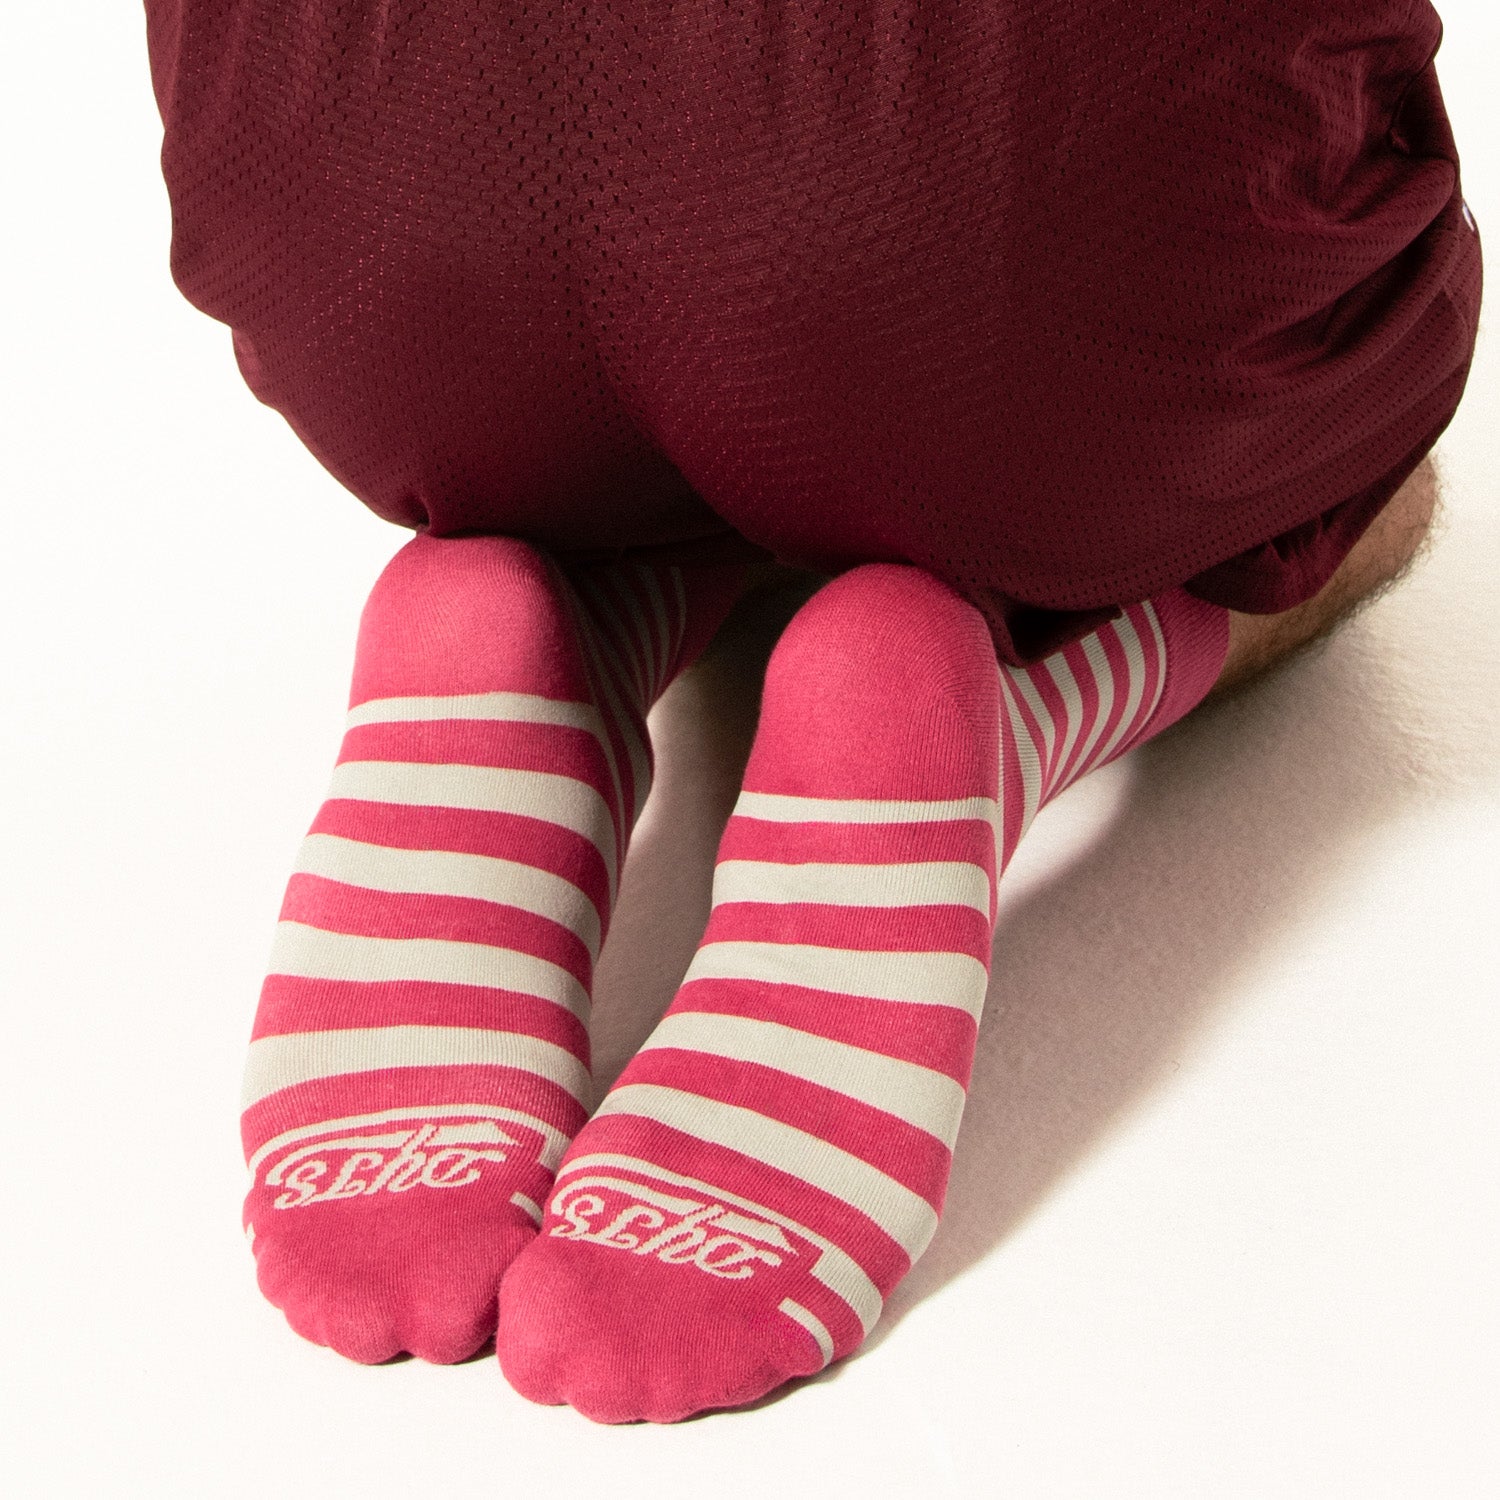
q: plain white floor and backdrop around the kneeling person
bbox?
[0,0,1500,1500]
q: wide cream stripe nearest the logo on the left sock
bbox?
[240,1026,591,1110]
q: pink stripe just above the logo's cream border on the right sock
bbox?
[561,1115,912,1296]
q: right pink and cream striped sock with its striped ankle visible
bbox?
[497,564,1229,1422]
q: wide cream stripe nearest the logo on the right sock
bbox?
[594,1083,938,1260]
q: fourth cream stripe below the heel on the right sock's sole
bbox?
[641,1011,965,1151]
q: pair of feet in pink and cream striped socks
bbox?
[243,537,1227,1422]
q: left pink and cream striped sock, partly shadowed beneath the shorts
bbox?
[243,536,743,1362]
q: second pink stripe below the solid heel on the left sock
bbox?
[309,798,609,923]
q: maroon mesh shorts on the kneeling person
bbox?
[146,0,1481,662]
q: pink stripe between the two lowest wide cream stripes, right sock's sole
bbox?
[624,1047,950,1211]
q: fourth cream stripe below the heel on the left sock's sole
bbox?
[269,923,588,1019]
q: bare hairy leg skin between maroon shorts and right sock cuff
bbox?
[1205,458,1440,702]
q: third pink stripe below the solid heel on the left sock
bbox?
[281,873,593,989]
